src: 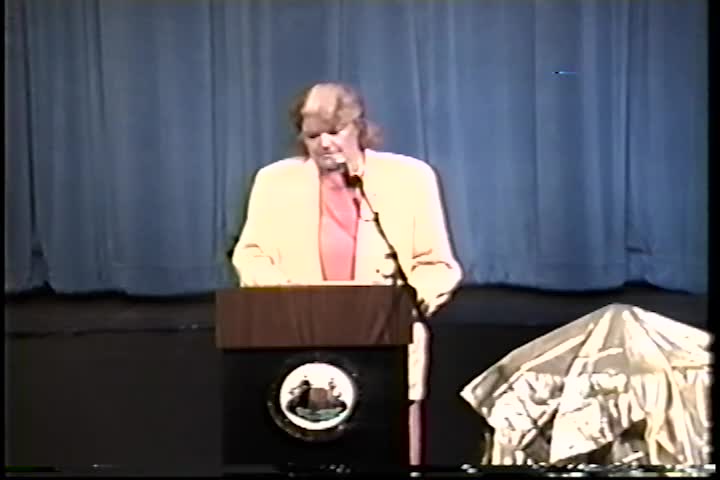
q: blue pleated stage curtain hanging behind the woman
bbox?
[5,0,708,295]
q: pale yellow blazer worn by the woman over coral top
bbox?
[232,150,462,399]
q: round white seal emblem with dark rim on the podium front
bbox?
[269,361,357,441]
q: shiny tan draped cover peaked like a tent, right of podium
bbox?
[460,304,712,465]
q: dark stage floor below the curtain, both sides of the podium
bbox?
[5,286,708,475]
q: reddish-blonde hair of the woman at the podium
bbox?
[290,83,382,155]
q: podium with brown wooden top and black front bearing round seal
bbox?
[216,285,413,471]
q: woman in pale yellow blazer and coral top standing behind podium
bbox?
[232,83,462,464]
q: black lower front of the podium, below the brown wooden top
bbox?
[223,346,409,471]
